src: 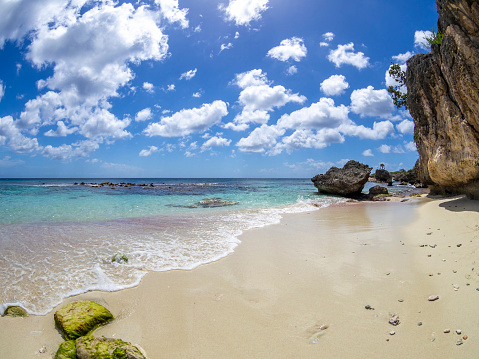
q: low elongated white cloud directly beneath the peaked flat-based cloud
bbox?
[268,128,344,156]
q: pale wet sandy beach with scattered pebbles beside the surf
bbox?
[0,197,479,359]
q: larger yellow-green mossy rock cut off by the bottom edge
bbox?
[76,336,146,359]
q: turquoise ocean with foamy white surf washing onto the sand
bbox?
[0,179,352,315]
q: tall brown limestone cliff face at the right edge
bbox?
[406,0,479,198]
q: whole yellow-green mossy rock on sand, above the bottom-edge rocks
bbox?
[54,300,114,340]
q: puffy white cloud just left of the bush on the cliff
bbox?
[351,86,394,118]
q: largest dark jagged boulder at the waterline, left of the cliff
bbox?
[311,161,372,197]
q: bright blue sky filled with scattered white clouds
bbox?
[0,0,437,178]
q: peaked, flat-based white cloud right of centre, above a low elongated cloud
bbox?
[278,98,349,130]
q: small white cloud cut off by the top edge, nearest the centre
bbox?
[219,0,269,26]
